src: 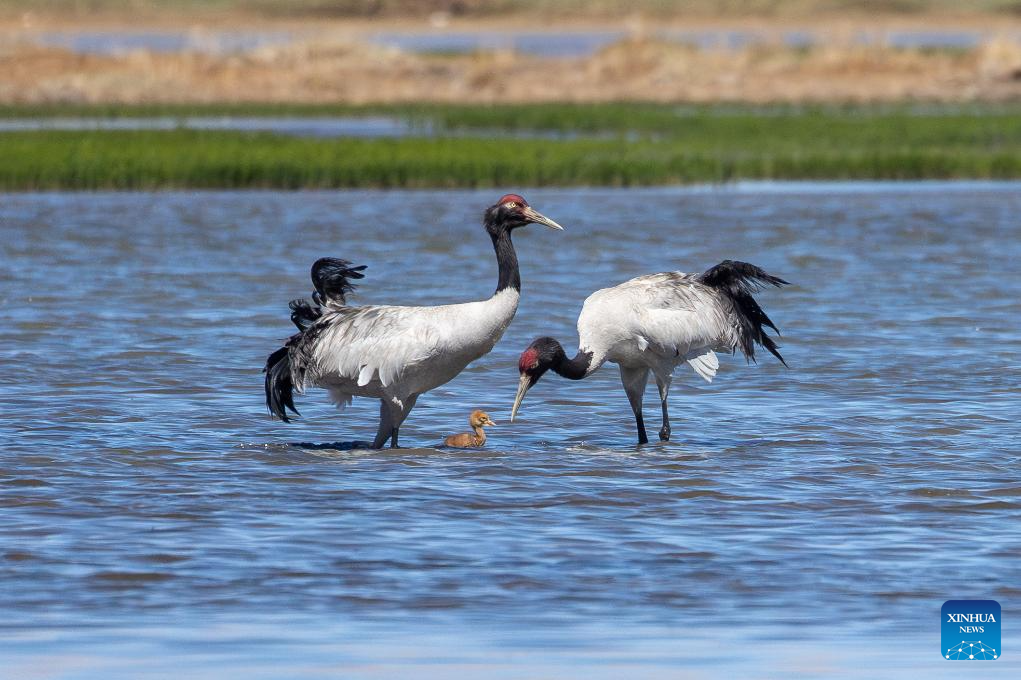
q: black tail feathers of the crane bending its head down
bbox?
[698,259,790,367]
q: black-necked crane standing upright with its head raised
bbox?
[264,194,563,448]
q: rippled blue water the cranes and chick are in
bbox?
[0,184,1021,678]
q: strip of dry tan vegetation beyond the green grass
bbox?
[0,32,1021,103]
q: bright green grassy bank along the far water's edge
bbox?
[0,104,1021,191]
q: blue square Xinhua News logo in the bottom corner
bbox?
[939,599,1003,661]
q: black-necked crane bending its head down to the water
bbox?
[511,259,787,444]
